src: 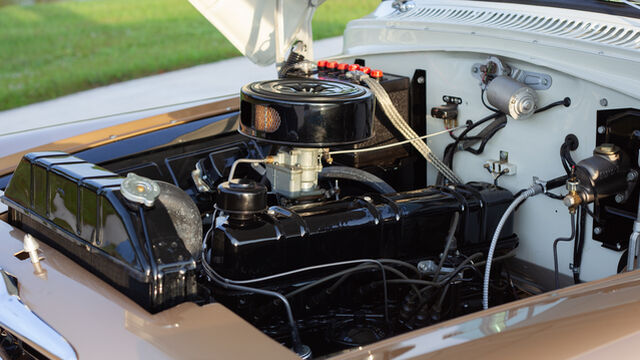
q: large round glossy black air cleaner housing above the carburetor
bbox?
[239,79,374,147]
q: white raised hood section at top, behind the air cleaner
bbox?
[189,0,325,66]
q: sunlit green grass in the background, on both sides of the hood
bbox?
[0,0,379,110]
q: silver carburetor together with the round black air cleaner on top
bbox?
[239,78,374,199]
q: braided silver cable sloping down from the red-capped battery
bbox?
[360,74,462,184]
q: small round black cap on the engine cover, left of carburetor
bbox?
[216,179,267,218]
